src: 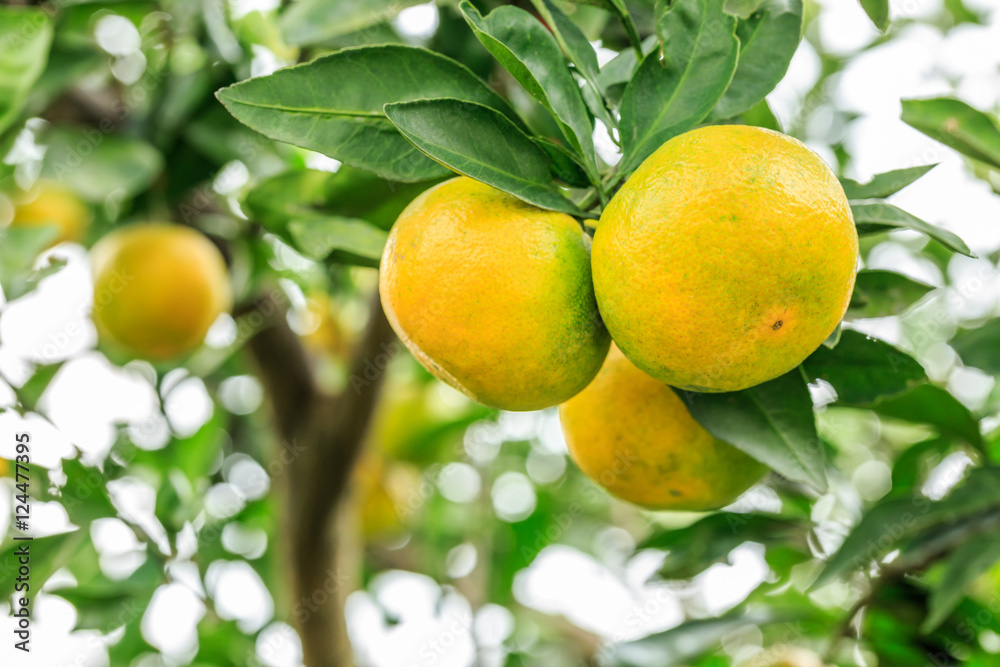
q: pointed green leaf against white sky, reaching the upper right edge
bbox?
[903,97,1000,169]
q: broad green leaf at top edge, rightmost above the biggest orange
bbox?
[709,0,802,120]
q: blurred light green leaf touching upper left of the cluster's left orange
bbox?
[288,216,389,266]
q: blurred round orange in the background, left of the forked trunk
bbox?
[91,223,232,360]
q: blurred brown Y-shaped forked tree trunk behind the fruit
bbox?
[242,294,394,667]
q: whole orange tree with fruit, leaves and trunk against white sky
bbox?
[0,0,1000,667]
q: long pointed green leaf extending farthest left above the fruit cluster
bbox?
[216,44,523,182]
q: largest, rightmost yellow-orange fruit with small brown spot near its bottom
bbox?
[593,125,858,392]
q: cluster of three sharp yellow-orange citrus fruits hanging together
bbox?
[379,125,858,509]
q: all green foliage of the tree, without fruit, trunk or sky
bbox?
[0,0,1000,667]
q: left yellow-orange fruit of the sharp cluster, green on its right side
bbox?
[379,178,610,410]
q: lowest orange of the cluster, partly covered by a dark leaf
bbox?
[559,345,766,511]
